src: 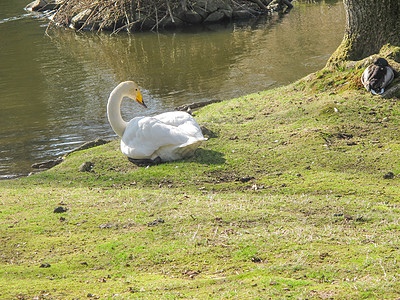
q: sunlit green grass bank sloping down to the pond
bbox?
[0,67,400,299]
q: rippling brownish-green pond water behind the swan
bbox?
[0,0,345,179]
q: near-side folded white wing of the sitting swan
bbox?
[121,117,204,160]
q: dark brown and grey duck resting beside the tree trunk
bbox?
[361,58,394,95]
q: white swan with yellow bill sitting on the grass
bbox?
[107,81,206,162]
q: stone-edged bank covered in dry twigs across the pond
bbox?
[25,0,293,32]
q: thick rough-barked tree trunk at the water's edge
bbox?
[328,0,400,66]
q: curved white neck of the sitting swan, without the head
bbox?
[107,85,128,137]
